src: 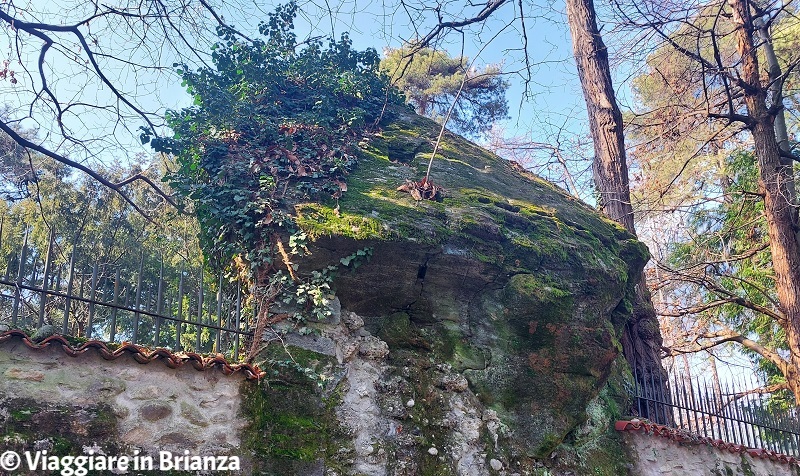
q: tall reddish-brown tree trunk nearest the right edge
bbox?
[730,0,800,405]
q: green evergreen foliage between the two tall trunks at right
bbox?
[668,151,793,405]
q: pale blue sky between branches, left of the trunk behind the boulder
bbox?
[7,0,632,199]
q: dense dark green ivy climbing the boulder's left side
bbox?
[142,2,402,356]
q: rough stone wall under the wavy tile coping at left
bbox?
[0,338,246,473]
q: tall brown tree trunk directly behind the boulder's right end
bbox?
[566,0,666,410]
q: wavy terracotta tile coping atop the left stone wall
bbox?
[0,330,264,380]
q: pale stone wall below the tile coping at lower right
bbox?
[622,431,800,476]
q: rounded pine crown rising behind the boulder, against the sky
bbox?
[381,43,509,136]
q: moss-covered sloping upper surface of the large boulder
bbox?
[300,110,630,276]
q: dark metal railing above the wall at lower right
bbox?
[633,360,800,457]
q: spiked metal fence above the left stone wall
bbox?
[0,226,252,361]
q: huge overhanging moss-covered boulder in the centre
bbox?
[247,110,648,475]
